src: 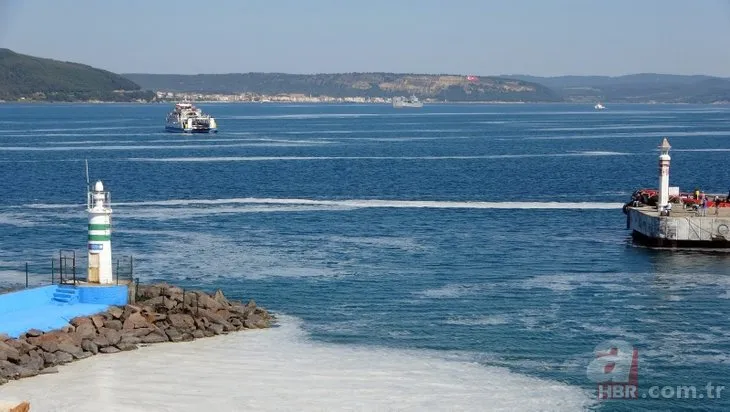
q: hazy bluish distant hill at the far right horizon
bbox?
[504,73,730,103]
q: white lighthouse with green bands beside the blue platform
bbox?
[87,180,113,284]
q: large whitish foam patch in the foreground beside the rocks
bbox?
[2,317,595,412]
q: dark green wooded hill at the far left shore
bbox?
[0,49,154,101]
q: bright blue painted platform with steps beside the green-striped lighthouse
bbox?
[0,285,128,338]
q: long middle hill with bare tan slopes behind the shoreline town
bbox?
[124,73,561,102]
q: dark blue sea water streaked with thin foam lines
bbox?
[0,104,730,411]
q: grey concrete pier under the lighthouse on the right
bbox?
[627,206,730,249]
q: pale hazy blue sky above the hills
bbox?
[0,0,730,76]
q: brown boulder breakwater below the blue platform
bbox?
[0,284,275,385]
